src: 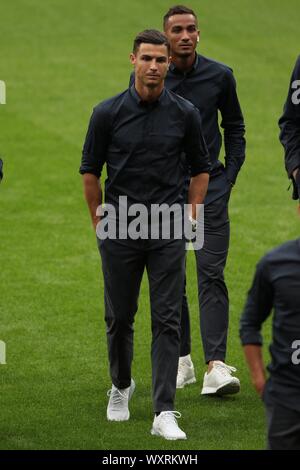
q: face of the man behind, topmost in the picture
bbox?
[165,14,199,57]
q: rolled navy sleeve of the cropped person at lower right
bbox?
[240,257,274,345]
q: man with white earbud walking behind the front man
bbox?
[164,6,245,394]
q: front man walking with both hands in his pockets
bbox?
[80,30,210,439]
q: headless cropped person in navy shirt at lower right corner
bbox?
[240,238,300,450]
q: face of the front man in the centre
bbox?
[130,43,170,88]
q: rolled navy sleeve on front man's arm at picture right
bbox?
[184,106,211,176]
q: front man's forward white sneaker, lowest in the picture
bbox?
[151,411,186,441]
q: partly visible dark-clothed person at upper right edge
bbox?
[279,56,300,199]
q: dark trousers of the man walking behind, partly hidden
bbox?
[180,191,230,363]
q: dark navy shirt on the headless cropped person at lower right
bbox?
[240,239,300,411]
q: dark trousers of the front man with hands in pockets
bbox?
[98,235,185,412]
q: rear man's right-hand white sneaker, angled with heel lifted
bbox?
[201,361,241,395]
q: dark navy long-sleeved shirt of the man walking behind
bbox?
[130,54,246,204]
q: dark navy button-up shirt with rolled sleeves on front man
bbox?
[80,86,210,209]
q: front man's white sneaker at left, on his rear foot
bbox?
[107,379,135,421]
